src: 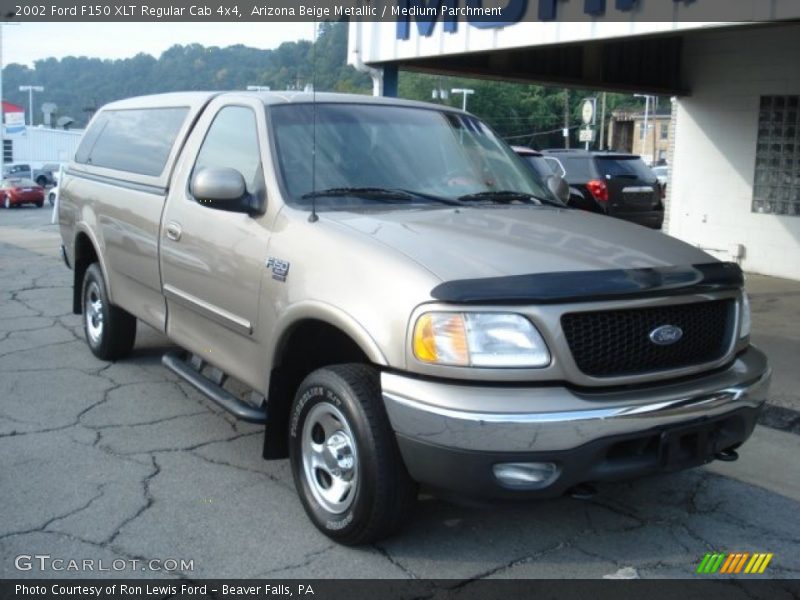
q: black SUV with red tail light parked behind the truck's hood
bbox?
[543,150,664,229]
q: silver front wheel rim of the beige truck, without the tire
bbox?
[301,402,358,514]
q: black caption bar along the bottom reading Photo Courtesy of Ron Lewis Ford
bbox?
[0,573,800,600]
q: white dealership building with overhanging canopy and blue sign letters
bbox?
[349,0,800,280]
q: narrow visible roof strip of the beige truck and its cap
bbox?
[103,91,461,112]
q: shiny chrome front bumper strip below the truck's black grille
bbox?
[381,347,771,452]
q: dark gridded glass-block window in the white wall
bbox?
[753,96,800,217]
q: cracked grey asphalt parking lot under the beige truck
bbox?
[0,208,800,582]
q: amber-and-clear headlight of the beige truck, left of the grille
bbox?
[413,312,550,367]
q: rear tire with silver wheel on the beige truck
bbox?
[81,263,136,360]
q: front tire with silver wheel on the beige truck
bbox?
[289,364,417,546]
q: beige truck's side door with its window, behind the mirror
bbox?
[160,98,269,385]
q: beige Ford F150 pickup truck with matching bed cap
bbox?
[59,93,770,544]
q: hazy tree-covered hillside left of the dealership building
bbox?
[3,23,372,127]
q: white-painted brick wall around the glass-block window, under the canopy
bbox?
[667,24,800,280]
